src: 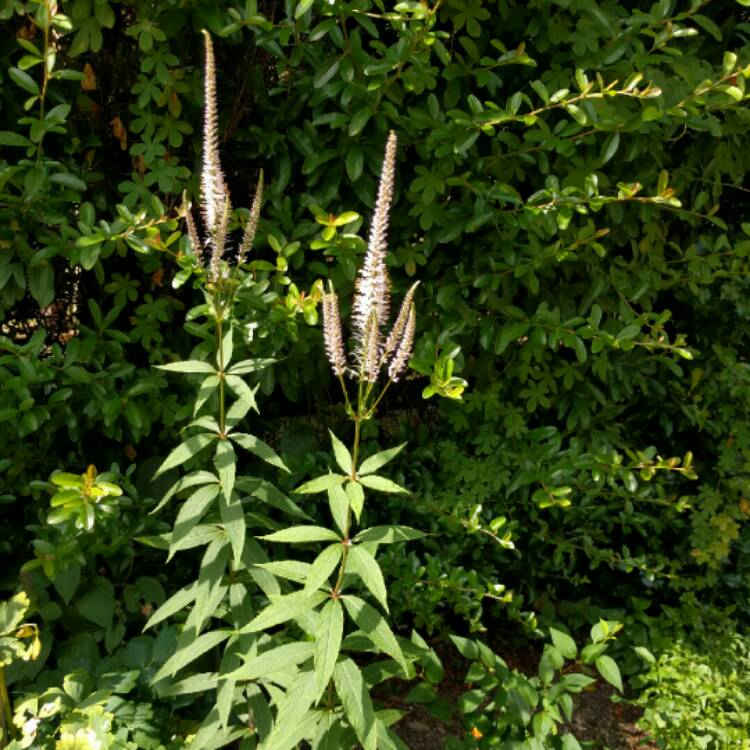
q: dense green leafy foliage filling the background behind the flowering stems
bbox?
[0,0,750,748]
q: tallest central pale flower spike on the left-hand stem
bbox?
[201,29,229,247]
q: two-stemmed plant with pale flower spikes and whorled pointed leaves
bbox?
[147,34,428,750]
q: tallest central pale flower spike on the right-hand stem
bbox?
[352,131,396,344]
